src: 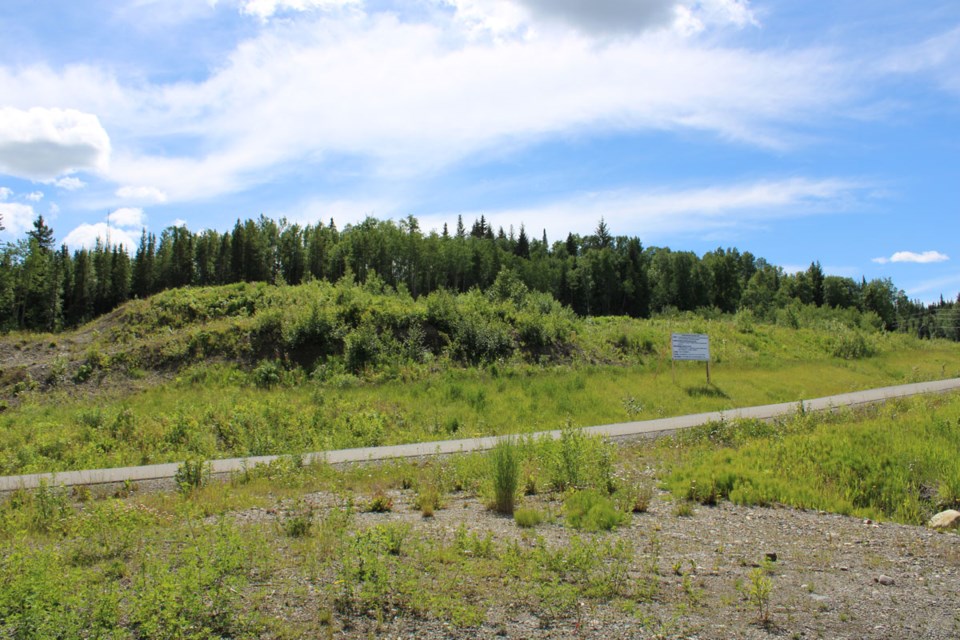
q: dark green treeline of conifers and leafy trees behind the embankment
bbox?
[0,216,960,340]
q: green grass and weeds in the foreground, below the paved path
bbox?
[0,394,960,638]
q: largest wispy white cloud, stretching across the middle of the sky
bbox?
[103,15,852,201]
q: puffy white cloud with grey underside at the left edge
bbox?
[0,107,110,180]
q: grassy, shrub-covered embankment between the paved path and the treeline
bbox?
[0,282,960,474]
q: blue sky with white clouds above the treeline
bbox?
[0,0,960,302]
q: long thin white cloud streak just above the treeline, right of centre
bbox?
[432,178,867,242]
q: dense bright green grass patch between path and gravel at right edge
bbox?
[668,395,960,524]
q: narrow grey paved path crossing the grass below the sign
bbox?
[0,378,960,492]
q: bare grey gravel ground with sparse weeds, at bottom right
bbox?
[236,492,960,640]
